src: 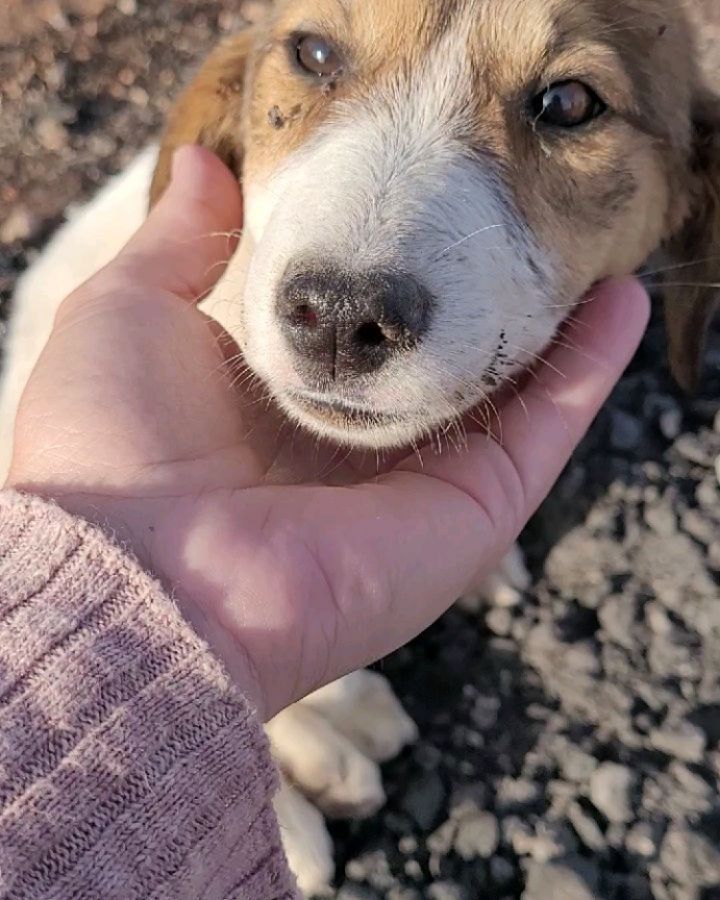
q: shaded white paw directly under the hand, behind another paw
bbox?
[302,669,418,762]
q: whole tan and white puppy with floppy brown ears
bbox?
[0,0,720,893]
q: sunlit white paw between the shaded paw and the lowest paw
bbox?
[266,703,385,818]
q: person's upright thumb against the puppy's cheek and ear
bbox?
[111,145,242,302]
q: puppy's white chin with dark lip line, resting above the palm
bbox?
[277,391,441,450]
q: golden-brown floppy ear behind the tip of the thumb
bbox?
[150,28,256,207]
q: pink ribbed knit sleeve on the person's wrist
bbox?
[0,491,298,900]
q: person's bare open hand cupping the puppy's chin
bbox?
[8,148,649,717]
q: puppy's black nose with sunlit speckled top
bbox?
[278,266,432,381]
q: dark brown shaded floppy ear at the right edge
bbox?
[664,96,720,391]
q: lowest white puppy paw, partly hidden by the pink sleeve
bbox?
[274,778,335,897]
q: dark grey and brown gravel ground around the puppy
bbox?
[0,0,720,900]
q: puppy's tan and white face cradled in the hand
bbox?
[150,0,716,447]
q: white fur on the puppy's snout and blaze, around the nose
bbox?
[231,36,563,447]
